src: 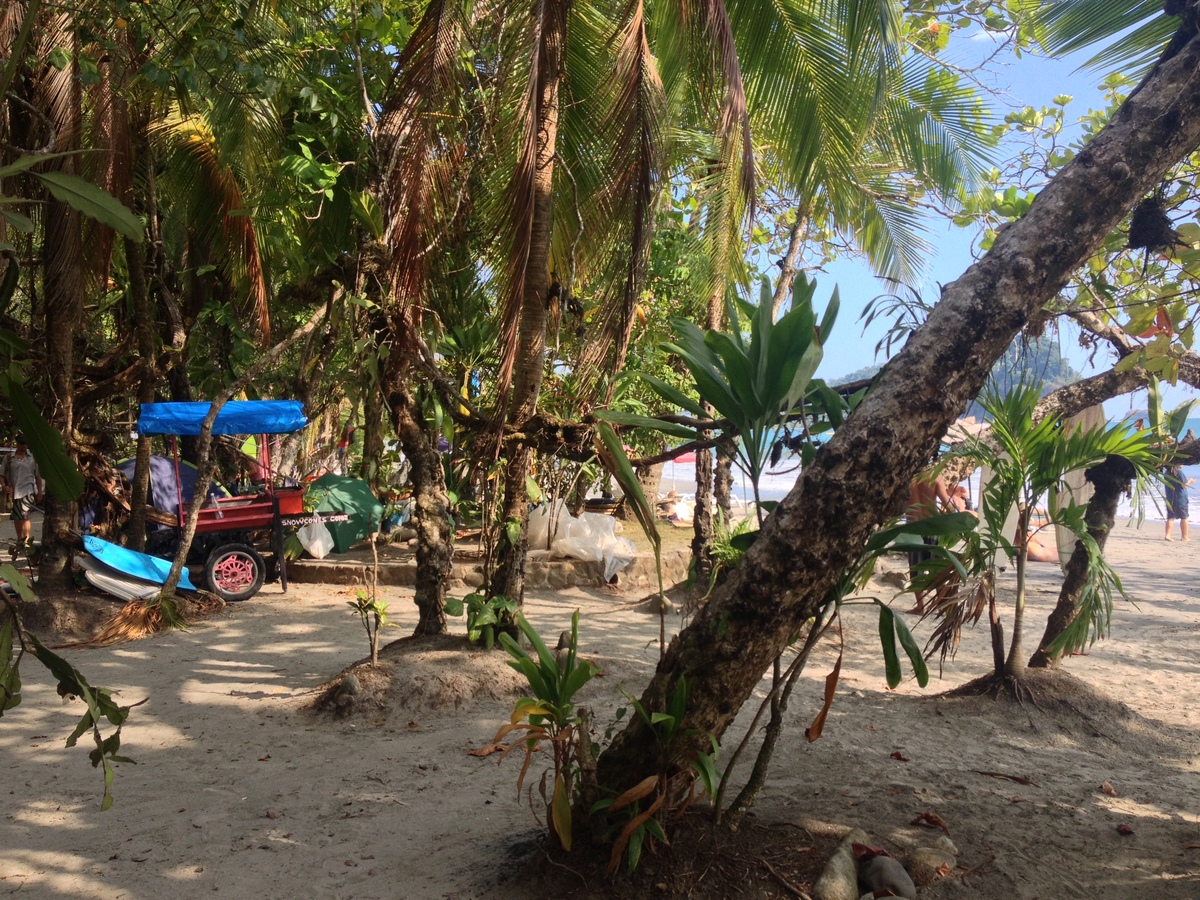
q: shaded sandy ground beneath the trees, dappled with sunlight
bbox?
[0,523,1200,900]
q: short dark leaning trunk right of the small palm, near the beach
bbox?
[1030,456,1136,668]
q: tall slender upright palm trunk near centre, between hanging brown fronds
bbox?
[490,2,568,601]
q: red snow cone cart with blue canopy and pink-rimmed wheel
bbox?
[138,400,308,600]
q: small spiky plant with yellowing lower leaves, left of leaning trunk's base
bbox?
[494,610,596,851]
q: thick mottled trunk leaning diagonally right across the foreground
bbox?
[599,29,1200,792]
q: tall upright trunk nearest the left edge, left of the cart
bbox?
[38,16,84,588]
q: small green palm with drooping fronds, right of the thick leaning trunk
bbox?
[931,384,1158,690]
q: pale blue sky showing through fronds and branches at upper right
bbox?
[816,30,1195,416]
